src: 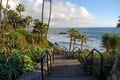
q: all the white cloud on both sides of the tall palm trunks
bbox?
[4,0,95,27]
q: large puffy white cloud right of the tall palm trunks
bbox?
[52,2,95,27]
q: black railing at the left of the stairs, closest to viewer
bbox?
[40,50,52,80]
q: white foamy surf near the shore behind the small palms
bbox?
[48,34,104,51]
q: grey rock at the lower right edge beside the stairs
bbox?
[108,52,120,80]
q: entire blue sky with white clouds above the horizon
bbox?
[3,0,120,28]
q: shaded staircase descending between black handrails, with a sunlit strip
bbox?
[45,55,97,80]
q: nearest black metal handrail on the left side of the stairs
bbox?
[40,49,52,80]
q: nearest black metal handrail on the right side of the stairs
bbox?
[85,49,103,80]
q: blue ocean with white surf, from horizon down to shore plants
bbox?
[48,28,120,51]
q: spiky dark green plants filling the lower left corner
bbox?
[0,49,34,80]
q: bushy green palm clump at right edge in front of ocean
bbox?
[102,33,120,54]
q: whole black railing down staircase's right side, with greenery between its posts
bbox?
[59,47,104,80]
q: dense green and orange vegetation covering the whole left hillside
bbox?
[0,4,49,80]
